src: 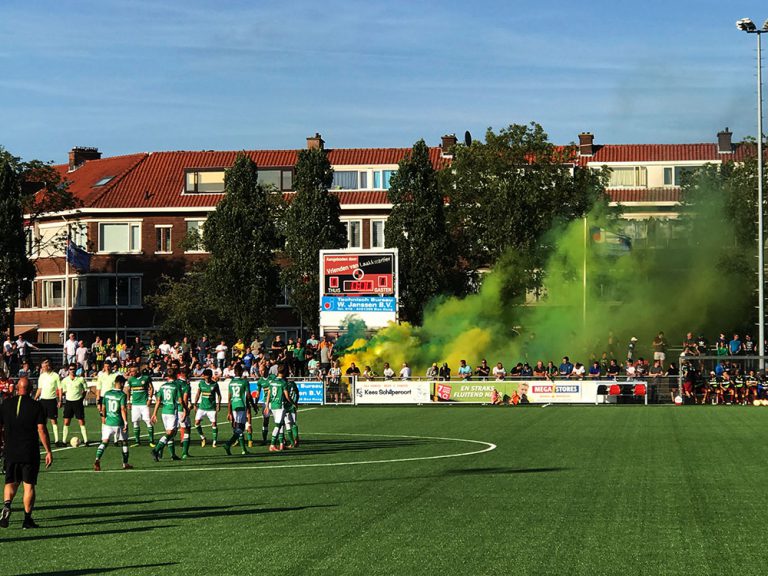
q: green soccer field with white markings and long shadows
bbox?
[0,406,768,576]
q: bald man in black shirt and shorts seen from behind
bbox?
[0,378,53,529]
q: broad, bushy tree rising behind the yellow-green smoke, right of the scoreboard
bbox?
[441,123,606,288]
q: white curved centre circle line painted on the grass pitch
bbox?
[48,432,496,474]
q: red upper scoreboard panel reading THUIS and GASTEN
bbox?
[322,253,395,296]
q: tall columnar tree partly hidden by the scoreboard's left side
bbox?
[281,149,347,327]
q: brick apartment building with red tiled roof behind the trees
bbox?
[16,129,756,344]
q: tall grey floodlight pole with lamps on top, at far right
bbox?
[736,18,768,370]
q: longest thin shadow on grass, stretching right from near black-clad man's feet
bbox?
[51,504,336,526]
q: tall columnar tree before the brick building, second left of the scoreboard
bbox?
[203,153,282,339]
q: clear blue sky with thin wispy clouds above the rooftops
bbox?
[0,0,768,162]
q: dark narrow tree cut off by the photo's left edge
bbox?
[0,149,35,333]
